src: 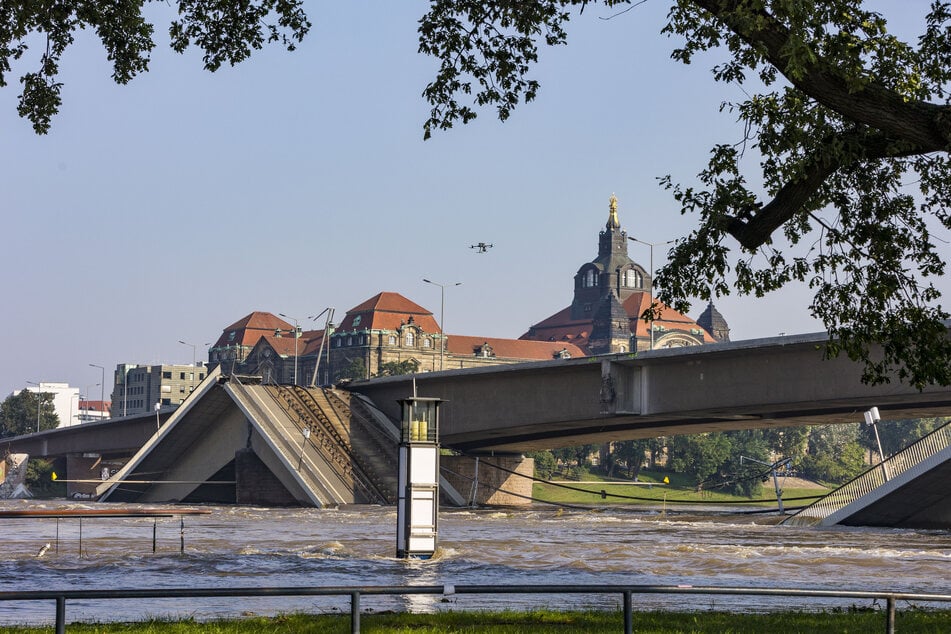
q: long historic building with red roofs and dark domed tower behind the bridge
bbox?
[206,196,729,386]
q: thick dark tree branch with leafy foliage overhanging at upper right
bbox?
[419,0,951,388]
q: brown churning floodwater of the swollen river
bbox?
[0,500,951,625]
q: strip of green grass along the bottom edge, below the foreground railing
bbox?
[0,610,951,634]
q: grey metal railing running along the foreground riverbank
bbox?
[0,585,951,634]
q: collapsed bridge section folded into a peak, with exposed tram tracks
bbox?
[97,369,398,507]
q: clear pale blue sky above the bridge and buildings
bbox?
[0,0,948,398]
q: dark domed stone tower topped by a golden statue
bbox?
[571,194,650,319]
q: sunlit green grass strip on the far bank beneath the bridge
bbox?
[532,472,830,509]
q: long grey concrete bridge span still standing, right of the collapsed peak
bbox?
[348,333,951,453]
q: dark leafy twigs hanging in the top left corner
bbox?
[0,0,311,134]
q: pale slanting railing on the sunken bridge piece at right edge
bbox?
[783,423,951,526]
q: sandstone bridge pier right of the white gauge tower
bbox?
[439,455,535,506]
